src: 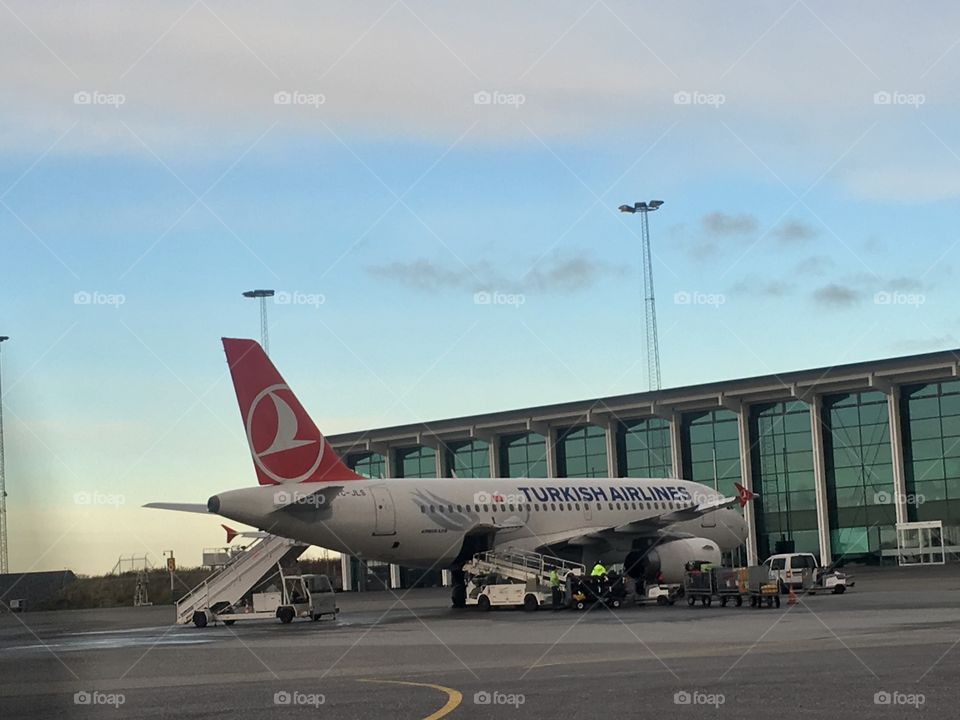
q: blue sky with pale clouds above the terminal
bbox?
[0,0,960,573]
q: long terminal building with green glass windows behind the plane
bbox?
[327,349,960,587]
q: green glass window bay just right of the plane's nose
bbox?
[750,400,820,560]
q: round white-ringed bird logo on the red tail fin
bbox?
[247,384,326,483]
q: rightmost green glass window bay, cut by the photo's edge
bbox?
[900,380,960,526]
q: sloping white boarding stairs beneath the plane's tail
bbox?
[177,535,308,625]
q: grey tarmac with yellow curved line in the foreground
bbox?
[0,566,960,720]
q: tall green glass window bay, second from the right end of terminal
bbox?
[822,391,897,560]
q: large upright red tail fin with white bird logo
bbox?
[223,338,362,485]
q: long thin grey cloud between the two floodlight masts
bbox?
[364,252,627,293]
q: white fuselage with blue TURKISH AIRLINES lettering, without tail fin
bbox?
[208,478,747,567]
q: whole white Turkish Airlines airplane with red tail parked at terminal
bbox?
[145,338,754,607]
